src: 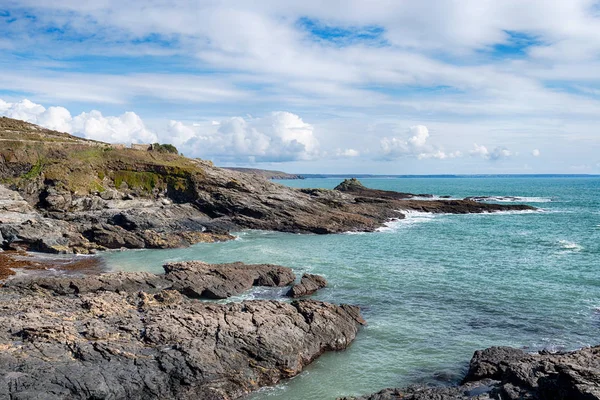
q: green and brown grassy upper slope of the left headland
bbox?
[0,118,204,196]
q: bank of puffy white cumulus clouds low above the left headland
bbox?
[0,99,318,162]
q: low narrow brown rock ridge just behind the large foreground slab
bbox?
[5,261,296,299]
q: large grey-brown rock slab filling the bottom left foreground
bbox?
[0,288,363,400]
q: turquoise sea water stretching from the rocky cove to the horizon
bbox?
[104,177,600,400]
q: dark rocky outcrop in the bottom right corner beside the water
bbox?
[344,346,600,400]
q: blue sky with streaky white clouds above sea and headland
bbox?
[0,0,600,174]
